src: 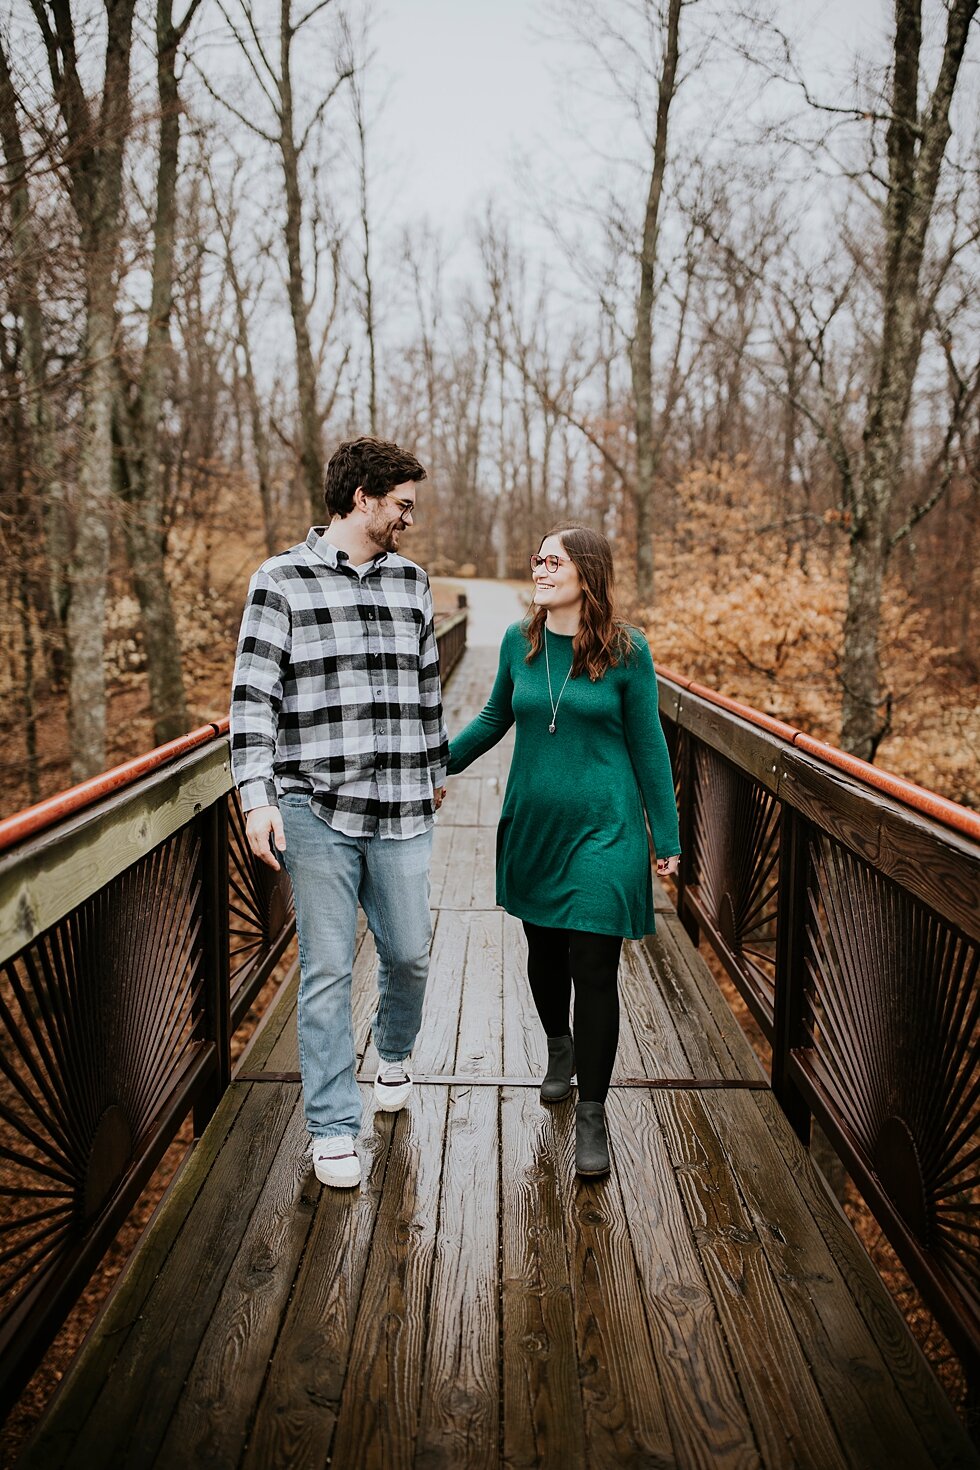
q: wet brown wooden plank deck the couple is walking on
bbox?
[22,650,980,1470]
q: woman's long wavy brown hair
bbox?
[525,526,633,681]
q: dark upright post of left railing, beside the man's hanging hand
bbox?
[194,797,231,1136]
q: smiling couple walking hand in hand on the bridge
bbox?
[231,438,680,1188]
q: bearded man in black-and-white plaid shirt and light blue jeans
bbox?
[231,438,448,1188]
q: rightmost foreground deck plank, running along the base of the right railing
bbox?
[740,1092,980,1470]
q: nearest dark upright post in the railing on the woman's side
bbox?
[771,804,810,1145]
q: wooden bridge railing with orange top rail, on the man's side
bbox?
[0,612,466,1416]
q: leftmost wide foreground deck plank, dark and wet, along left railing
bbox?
[66,1083,295,1470]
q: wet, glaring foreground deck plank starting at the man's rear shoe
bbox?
[332,1088,448,1470]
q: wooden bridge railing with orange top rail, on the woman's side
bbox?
[660,673,980,1397]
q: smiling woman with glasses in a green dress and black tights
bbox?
[450,526,680,1175]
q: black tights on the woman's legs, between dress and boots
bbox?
[525,923,623,1103]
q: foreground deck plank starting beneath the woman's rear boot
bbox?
[501,1088,586,1470]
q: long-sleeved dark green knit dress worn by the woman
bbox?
[450,623,680,939]
